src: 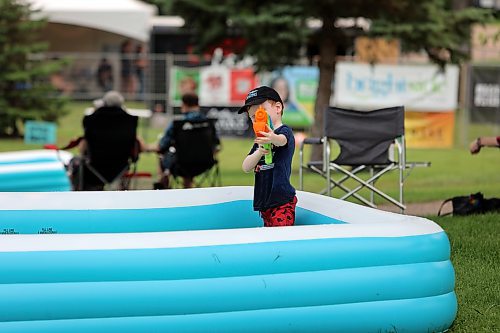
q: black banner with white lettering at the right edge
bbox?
[468,66,500,124]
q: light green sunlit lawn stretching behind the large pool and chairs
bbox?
[0,102,500,203]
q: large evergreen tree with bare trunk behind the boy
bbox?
[167,0,491,159]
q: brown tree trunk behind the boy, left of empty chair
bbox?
[311,17,337,161]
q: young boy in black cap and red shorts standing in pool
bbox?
[238,86,297,227]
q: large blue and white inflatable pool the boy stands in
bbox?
[0,187,457,333]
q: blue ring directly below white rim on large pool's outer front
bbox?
[0,232,450,283]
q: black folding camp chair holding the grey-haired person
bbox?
[74,106,144,190]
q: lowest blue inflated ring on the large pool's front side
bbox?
[0,292,457,333]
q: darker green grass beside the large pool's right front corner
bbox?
[432,213,500,333]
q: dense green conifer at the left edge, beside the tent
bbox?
[0,0,65,136]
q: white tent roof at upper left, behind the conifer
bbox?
[28,0,156,41]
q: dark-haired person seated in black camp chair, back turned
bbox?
[149,93,220,189]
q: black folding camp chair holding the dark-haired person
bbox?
[162,119,222,187]
